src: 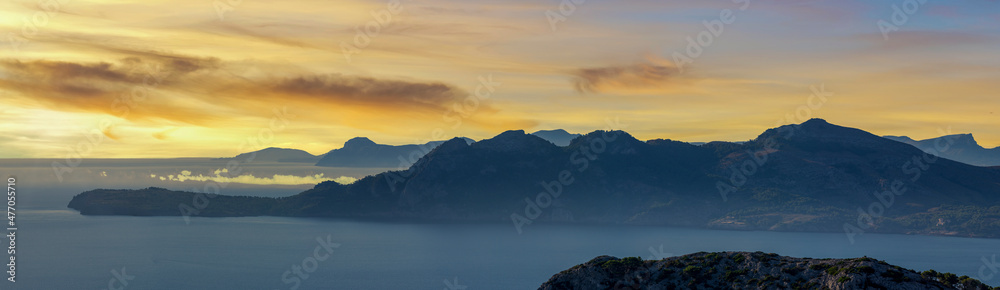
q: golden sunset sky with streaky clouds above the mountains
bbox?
[0,0,1000,158]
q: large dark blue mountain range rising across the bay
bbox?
[71,119,1000,237]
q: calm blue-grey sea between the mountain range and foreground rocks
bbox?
[0,160,1000,290]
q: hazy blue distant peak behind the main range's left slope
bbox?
[316,137,475,168]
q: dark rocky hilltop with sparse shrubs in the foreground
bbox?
[538,252,1000,290]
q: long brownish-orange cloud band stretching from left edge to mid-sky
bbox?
[0,53,516,130]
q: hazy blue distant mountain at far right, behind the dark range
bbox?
[884,134,1000,166]
